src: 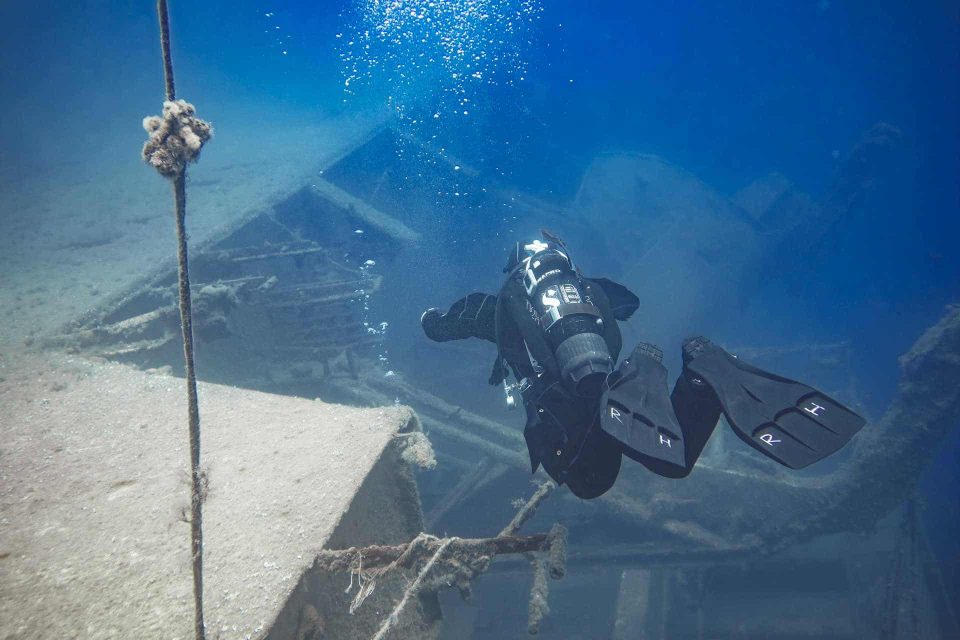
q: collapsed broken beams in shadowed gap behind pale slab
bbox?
[45,191,406,386]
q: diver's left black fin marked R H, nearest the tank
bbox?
[600,343,685,473]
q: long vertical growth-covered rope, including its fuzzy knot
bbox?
[143,0,213,640]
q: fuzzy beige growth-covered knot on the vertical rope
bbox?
[142,100,213,178]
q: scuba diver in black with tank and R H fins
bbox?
[420,230,865,499]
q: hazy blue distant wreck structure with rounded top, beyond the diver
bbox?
[575,124,902,344]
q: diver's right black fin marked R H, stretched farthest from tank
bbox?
[683,337,866,469]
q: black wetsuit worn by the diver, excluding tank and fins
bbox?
[422,270,720,498]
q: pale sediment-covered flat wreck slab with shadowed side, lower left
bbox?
[0,353,436,639]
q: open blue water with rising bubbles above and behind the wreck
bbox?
[0,0,960,638]
